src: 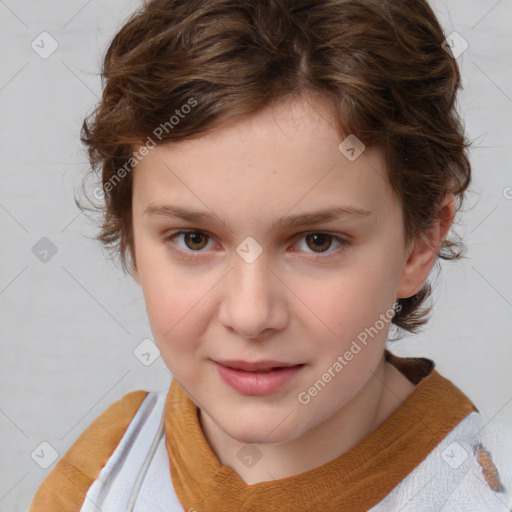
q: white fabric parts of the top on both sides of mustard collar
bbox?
[80,391,512,512]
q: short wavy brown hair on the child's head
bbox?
[75,0,471,332]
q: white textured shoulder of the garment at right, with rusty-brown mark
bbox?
[371,412,512,512]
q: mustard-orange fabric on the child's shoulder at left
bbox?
[29,390,148,512]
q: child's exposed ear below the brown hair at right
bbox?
[396,194,456,299]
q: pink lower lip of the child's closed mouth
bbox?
[215,363,304,396]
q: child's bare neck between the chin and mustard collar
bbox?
[199,356,415,485]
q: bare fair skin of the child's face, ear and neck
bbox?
[132,92,454,484]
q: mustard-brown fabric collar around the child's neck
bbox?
[164,350,478,512]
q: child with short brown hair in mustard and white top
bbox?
[30,0,512,512]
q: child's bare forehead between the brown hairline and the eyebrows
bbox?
[133,97,393,223]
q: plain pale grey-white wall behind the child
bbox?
[0,0,512,512]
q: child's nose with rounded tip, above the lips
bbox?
[219,255,289,340]
